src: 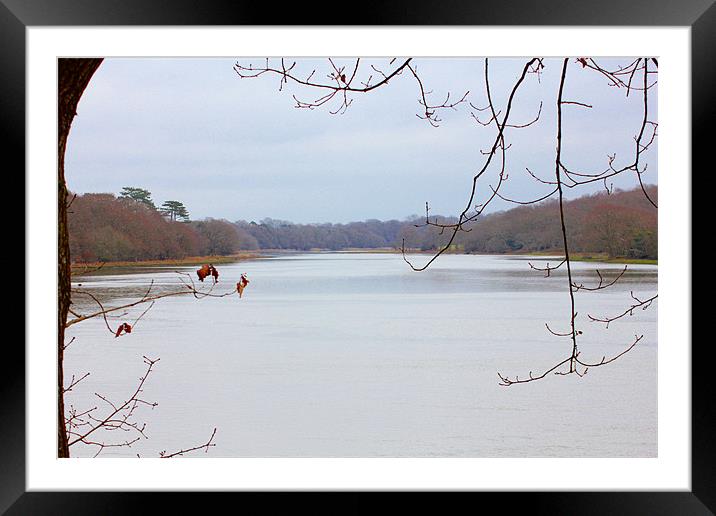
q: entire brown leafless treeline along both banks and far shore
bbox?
[69,186,658,261]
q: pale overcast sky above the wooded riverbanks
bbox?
[66,58,658,223]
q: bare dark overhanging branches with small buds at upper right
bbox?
[234,57,659,386]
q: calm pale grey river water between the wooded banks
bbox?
[65,253,657,457]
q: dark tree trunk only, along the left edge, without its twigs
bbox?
[57,59,102,457]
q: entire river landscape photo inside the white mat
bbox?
[57,56,659,458]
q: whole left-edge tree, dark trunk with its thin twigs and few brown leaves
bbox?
[57,59,237,458]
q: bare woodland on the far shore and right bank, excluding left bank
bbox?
[236,186,658,258]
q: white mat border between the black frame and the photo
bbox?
[26,27,691,491]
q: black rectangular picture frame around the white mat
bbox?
[5,0,716,515]
